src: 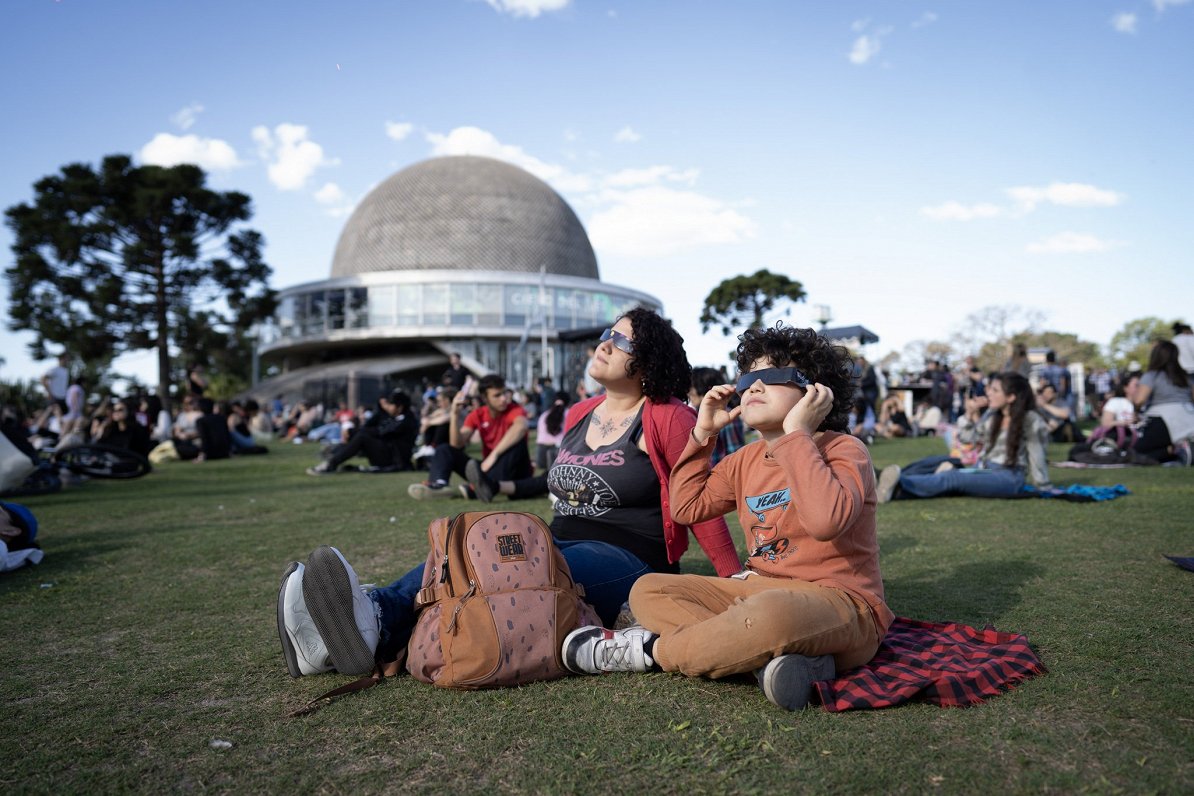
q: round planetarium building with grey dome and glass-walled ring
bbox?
[253,156,661,406]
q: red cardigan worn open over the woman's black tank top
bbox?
[564,395,743,578]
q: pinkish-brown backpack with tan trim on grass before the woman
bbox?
[406,512,601,689]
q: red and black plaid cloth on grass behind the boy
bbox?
[816,617,1046,711]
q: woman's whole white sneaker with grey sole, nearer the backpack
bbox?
[302,544,381,674]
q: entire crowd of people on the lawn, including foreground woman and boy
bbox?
[9,308,1194,709]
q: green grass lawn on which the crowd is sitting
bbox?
[0,439,1194,794]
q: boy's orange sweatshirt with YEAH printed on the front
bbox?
[671,431,893,638]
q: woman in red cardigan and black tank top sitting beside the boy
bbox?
[278,308,741,677]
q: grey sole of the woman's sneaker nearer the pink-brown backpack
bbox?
[302,544,374,674]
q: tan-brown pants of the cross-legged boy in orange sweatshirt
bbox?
[630,574,879,678]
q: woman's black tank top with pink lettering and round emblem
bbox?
[547,408,679,572]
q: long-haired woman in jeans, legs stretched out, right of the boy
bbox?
[879,371,1052,502]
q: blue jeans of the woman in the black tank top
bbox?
[369,539,653,661]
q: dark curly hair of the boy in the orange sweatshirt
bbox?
[737,322,854,431]
